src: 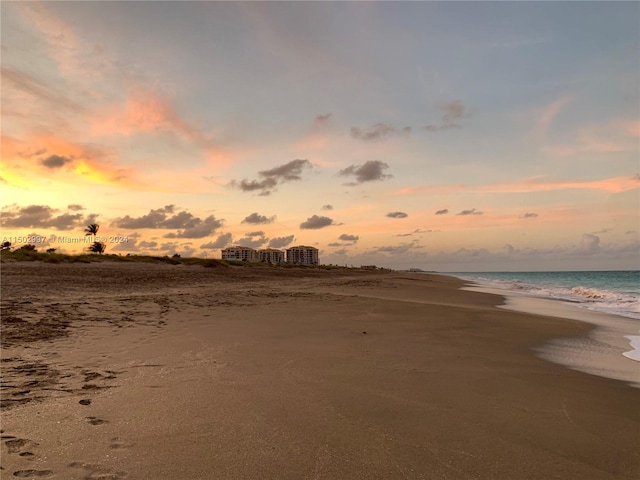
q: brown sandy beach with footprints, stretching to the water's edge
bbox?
[1,263,640,480]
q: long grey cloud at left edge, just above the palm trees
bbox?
[1,205,96,230]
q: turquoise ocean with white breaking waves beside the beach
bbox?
[449,270,640,320]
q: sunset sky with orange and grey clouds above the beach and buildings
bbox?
[0,1,640,272]
